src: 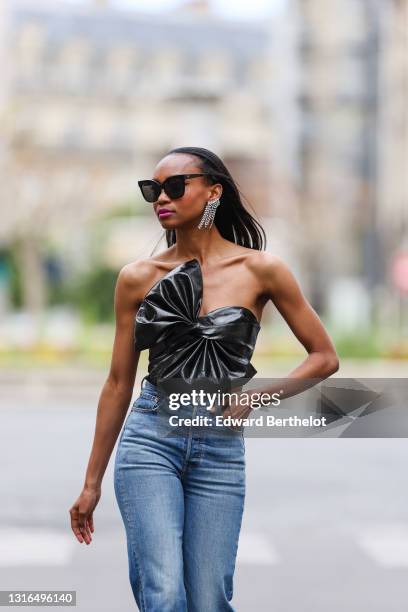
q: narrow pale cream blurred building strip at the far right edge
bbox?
[376,0,408,337]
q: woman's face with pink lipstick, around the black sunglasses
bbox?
[152,153,222,229]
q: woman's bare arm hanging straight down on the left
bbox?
[69,262,145,544]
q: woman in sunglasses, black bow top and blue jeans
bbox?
[70,147,338,612]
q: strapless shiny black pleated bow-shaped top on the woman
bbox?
[134,259,260,386]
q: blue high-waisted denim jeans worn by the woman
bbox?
[114,379,245,612]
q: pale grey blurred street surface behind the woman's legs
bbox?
[0,368,408,612]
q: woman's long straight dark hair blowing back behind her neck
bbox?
[158,147,266,251]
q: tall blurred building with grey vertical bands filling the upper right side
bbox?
[296,0,408,328]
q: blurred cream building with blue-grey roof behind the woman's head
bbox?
[0,0,297,316]
